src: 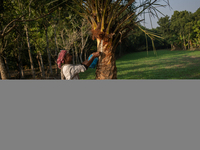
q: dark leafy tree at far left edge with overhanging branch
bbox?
[0,0,62,79]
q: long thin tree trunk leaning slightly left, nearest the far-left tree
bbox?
[24,25,35,79]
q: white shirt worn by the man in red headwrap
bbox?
[63,64,86,80]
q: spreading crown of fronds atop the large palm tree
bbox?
[65,0,169,52]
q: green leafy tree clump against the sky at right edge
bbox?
[156,8,200,50]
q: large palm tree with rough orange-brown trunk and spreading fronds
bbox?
[69,0,169,79]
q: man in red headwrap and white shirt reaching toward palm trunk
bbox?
[57,50,100,80]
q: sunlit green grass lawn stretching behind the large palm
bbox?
[80,50,200,80]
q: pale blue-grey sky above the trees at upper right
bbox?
[138,0,200,29]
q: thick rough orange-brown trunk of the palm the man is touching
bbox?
[96,39,117,80]
